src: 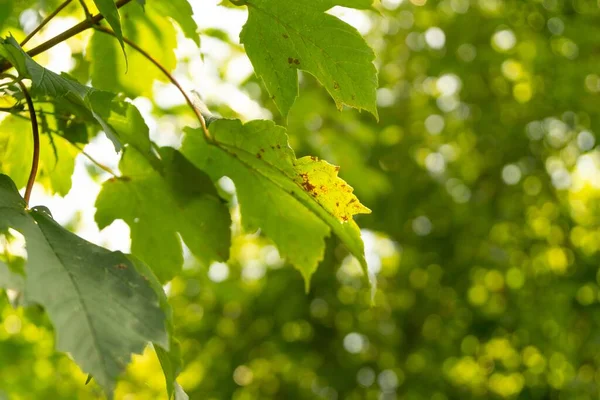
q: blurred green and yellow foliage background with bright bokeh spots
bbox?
[0,0,600,400]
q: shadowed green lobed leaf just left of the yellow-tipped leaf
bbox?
[96,149,231,282]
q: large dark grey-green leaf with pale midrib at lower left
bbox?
[0,175,169,397]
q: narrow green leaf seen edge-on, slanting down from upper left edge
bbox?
[0,37,154,159]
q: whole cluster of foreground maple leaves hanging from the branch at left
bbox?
[0,0,377,398]
